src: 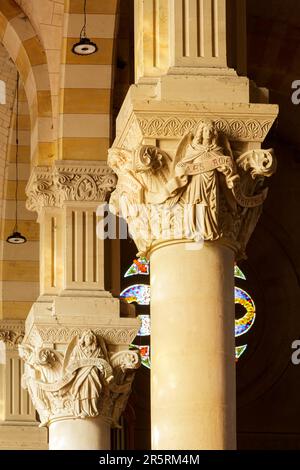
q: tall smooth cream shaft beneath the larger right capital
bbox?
[151,242,236,450]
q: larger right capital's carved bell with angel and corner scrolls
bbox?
[108,119,276,257]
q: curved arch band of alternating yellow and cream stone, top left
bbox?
[0,0,55,165]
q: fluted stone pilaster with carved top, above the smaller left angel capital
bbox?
[27,162,116,296]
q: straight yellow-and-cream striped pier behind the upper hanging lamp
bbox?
[59,0,119,161]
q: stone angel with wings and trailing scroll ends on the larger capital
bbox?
[150,120,269,241]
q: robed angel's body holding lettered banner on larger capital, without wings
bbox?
[175,121,238,240]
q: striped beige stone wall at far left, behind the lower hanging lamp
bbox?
[0,39,39,320]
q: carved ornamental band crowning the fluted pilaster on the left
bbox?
[26,162,116,212]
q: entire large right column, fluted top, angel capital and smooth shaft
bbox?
[109,0,278,449]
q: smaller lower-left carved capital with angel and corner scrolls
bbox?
[19,330,140,427]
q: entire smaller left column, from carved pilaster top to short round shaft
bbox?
[19,162,140,450]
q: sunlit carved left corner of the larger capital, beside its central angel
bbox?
[108,145,177,254]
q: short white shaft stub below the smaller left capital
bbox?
[49,418,110,450]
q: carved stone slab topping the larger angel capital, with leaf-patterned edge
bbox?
[113,98,278,149]
